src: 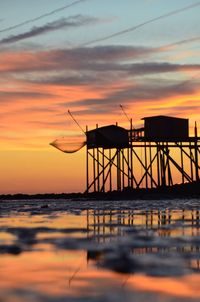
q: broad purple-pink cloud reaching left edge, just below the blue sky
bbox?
[0,46,157,73]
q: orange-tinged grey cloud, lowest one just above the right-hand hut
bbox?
[63,76,199,114]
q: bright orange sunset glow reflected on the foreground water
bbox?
[0,210,200,301]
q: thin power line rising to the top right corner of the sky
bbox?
[81,1,200,46]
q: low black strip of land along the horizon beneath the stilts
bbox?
[0,181,200,200]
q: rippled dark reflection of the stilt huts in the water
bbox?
[87,209,200,276]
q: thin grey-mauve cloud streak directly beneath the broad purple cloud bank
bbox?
[30,62,200,87]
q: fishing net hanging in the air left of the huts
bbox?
[50,137,86,153]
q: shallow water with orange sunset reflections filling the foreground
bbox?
[0,200,200,302]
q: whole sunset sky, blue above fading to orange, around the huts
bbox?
[0,0,200,194]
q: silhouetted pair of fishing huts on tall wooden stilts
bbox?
[86,116,200,193]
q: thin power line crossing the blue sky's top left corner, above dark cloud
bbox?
[0,0,88,33]
